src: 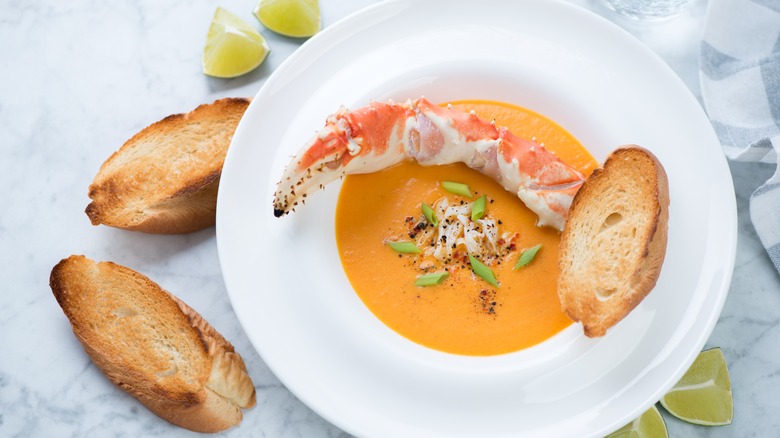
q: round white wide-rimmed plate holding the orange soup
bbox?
[217,0,736,437]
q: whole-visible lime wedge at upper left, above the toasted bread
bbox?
[203,7,270,78]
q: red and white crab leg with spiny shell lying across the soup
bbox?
[274,98,584,230]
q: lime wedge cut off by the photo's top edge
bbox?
[255,0,320,37]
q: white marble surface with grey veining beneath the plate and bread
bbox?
[0,0,780,437]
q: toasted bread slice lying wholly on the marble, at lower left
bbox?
[49,255,255,432]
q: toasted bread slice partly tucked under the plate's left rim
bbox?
[86,98,249,234]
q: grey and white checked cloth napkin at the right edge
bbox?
[700,0,780,272]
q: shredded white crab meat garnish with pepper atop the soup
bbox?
[409,197,516,268]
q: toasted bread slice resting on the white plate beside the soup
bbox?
[558,145,669,337]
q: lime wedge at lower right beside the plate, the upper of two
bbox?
[661,348,734,426]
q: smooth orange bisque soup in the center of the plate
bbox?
[336,100,597,356]
